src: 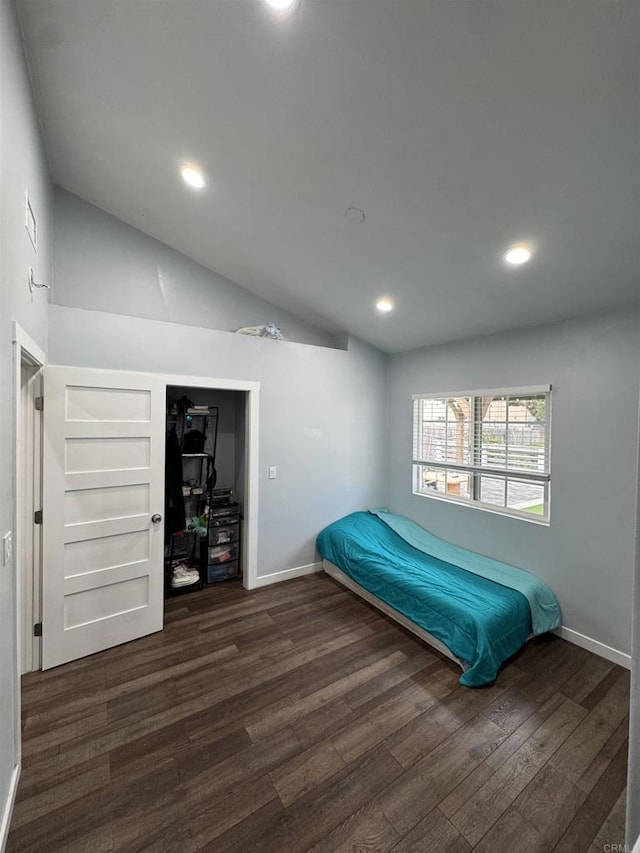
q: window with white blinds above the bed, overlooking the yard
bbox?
[413,386,551,521]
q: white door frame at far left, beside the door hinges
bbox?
[12,320,47,764]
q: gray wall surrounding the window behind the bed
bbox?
[388,309,640,653]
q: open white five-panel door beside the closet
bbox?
[42,367,166,669]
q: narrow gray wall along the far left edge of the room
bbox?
[0,0,52,828]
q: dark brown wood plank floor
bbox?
[8,575,629,853]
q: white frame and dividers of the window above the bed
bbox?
[412,385,551,526]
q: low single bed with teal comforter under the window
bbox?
[317,509,562,687]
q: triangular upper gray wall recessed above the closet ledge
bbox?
[54,188,342,347]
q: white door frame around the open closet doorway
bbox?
[161,373,260,589]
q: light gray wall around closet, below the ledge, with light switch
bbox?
[49,306,386,575]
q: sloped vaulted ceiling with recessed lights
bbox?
[18,0,640,352]
